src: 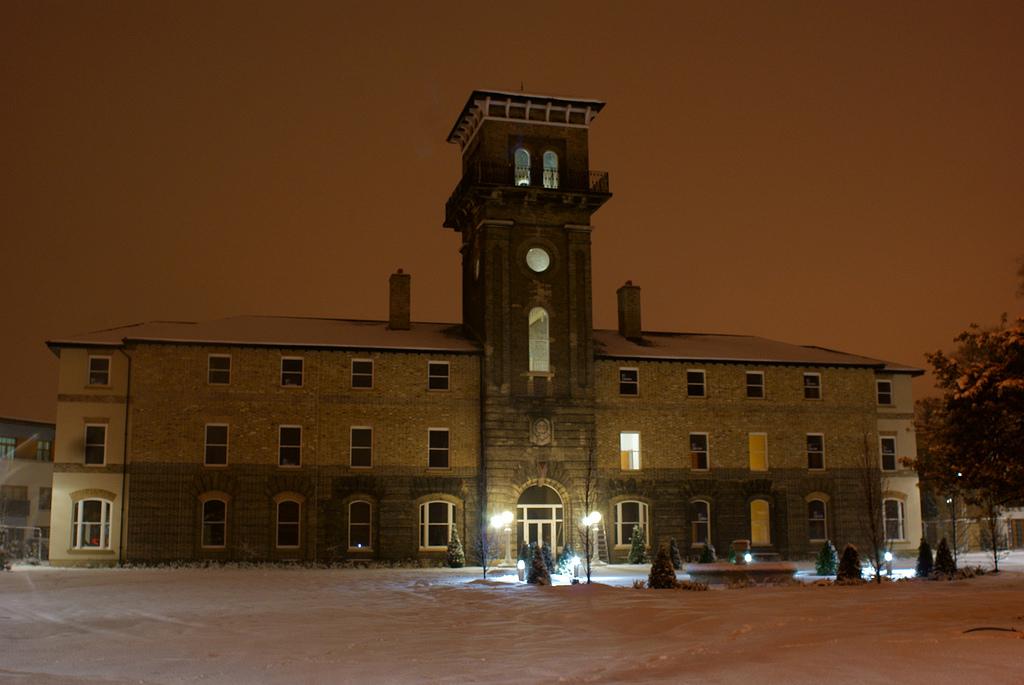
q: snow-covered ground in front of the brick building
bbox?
[0,553,1024,685]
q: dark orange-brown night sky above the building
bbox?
[0,2,1024,419]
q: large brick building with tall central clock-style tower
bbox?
[48,91,921,564]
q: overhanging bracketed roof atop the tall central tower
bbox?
[447,90,604,147]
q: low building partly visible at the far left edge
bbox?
[0,417,53,560]
